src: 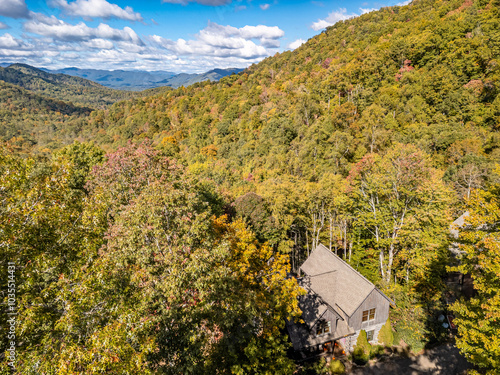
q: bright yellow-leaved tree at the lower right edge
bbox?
[452,167,500,374]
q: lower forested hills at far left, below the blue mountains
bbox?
[0,64,164,152]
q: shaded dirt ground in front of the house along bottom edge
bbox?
[349,344,472,375]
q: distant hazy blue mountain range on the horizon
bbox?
[43,68,243,91]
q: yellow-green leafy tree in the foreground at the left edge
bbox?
[0,145,103,374]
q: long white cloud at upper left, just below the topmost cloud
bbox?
[24,13,143,45]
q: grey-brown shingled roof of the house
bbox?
[300,244,375,316]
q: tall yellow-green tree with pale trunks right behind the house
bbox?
[348,144,451,283]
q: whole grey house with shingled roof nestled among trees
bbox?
[287,244,394,356]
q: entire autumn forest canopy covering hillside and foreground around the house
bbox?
[0,0,500,374]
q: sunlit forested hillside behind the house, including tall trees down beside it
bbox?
[78,0,500,366]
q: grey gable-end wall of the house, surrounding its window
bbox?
[349,289,389,331]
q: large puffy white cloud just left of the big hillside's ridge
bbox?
[152,22,285,59]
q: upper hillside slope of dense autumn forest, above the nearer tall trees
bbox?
[85,0,500,194]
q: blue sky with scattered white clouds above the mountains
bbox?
[0,0,401,72]
